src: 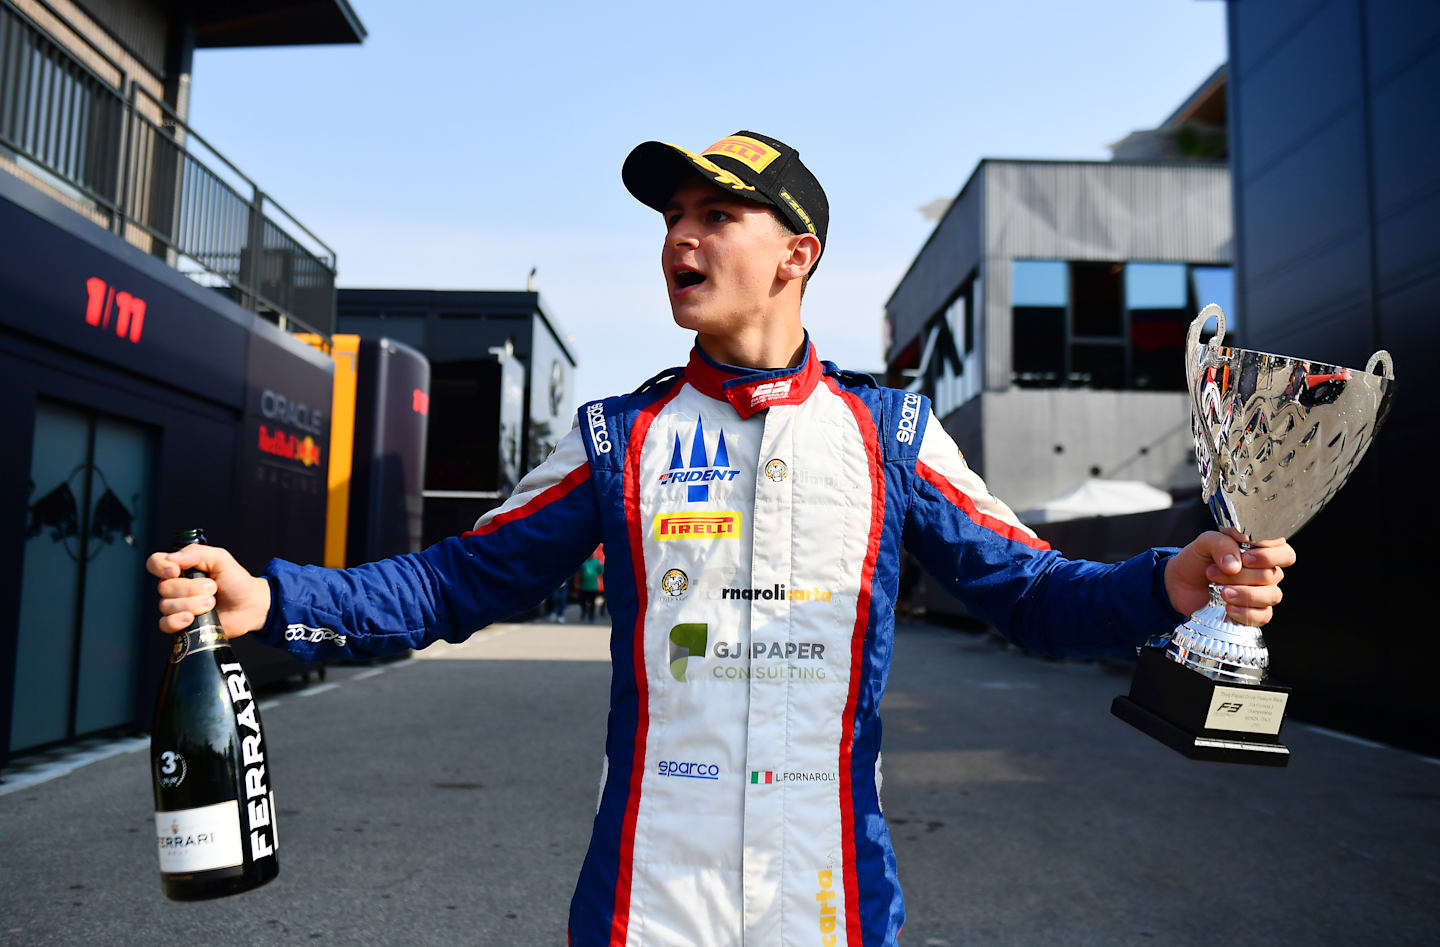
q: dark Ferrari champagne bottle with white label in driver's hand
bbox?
[150,530,279,901]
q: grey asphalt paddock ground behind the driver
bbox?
[0,609,1440,947]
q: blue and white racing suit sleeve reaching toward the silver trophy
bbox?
[904,416,1184,656]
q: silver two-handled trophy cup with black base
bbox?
[1110,304,1394,766]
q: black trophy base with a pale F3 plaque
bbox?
[1110,648,1290,766]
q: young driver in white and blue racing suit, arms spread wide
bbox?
[150,131,1295,947]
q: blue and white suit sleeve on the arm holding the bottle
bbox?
[258,430,600,661]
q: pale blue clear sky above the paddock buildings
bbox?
[190,0,1225,404]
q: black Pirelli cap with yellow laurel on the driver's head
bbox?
[621,131,829,272]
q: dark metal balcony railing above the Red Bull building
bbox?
[0,0,336,334]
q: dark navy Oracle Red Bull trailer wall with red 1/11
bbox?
[0,167,333,761]
